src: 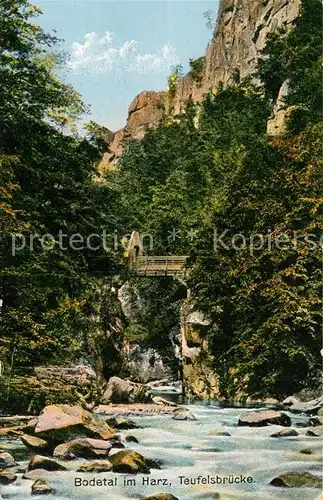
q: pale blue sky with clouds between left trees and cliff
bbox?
[35,0,218,130]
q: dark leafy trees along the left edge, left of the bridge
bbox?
[0,0,119,382]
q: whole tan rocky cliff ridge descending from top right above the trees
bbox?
[101,0,301,167]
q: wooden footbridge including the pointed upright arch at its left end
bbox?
[127,231,187,277]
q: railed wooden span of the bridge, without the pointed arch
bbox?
[132,255,187,276]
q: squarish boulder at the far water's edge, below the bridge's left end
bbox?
[101,377,152,404]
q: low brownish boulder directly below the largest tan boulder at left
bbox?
[53,438,112,460]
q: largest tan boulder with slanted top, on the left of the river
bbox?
[35,404,115,444]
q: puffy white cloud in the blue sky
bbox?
[68,31,180,75]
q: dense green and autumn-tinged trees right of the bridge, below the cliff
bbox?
[114,0,322,398]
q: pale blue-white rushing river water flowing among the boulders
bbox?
[0,405,321,500]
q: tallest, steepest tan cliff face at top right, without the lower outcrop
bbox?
[174,0,300,113]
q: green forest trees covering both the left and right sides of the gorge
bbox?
[0,0,322,410]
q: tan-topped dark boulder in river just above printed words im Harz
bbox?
[109,450,160,474]
